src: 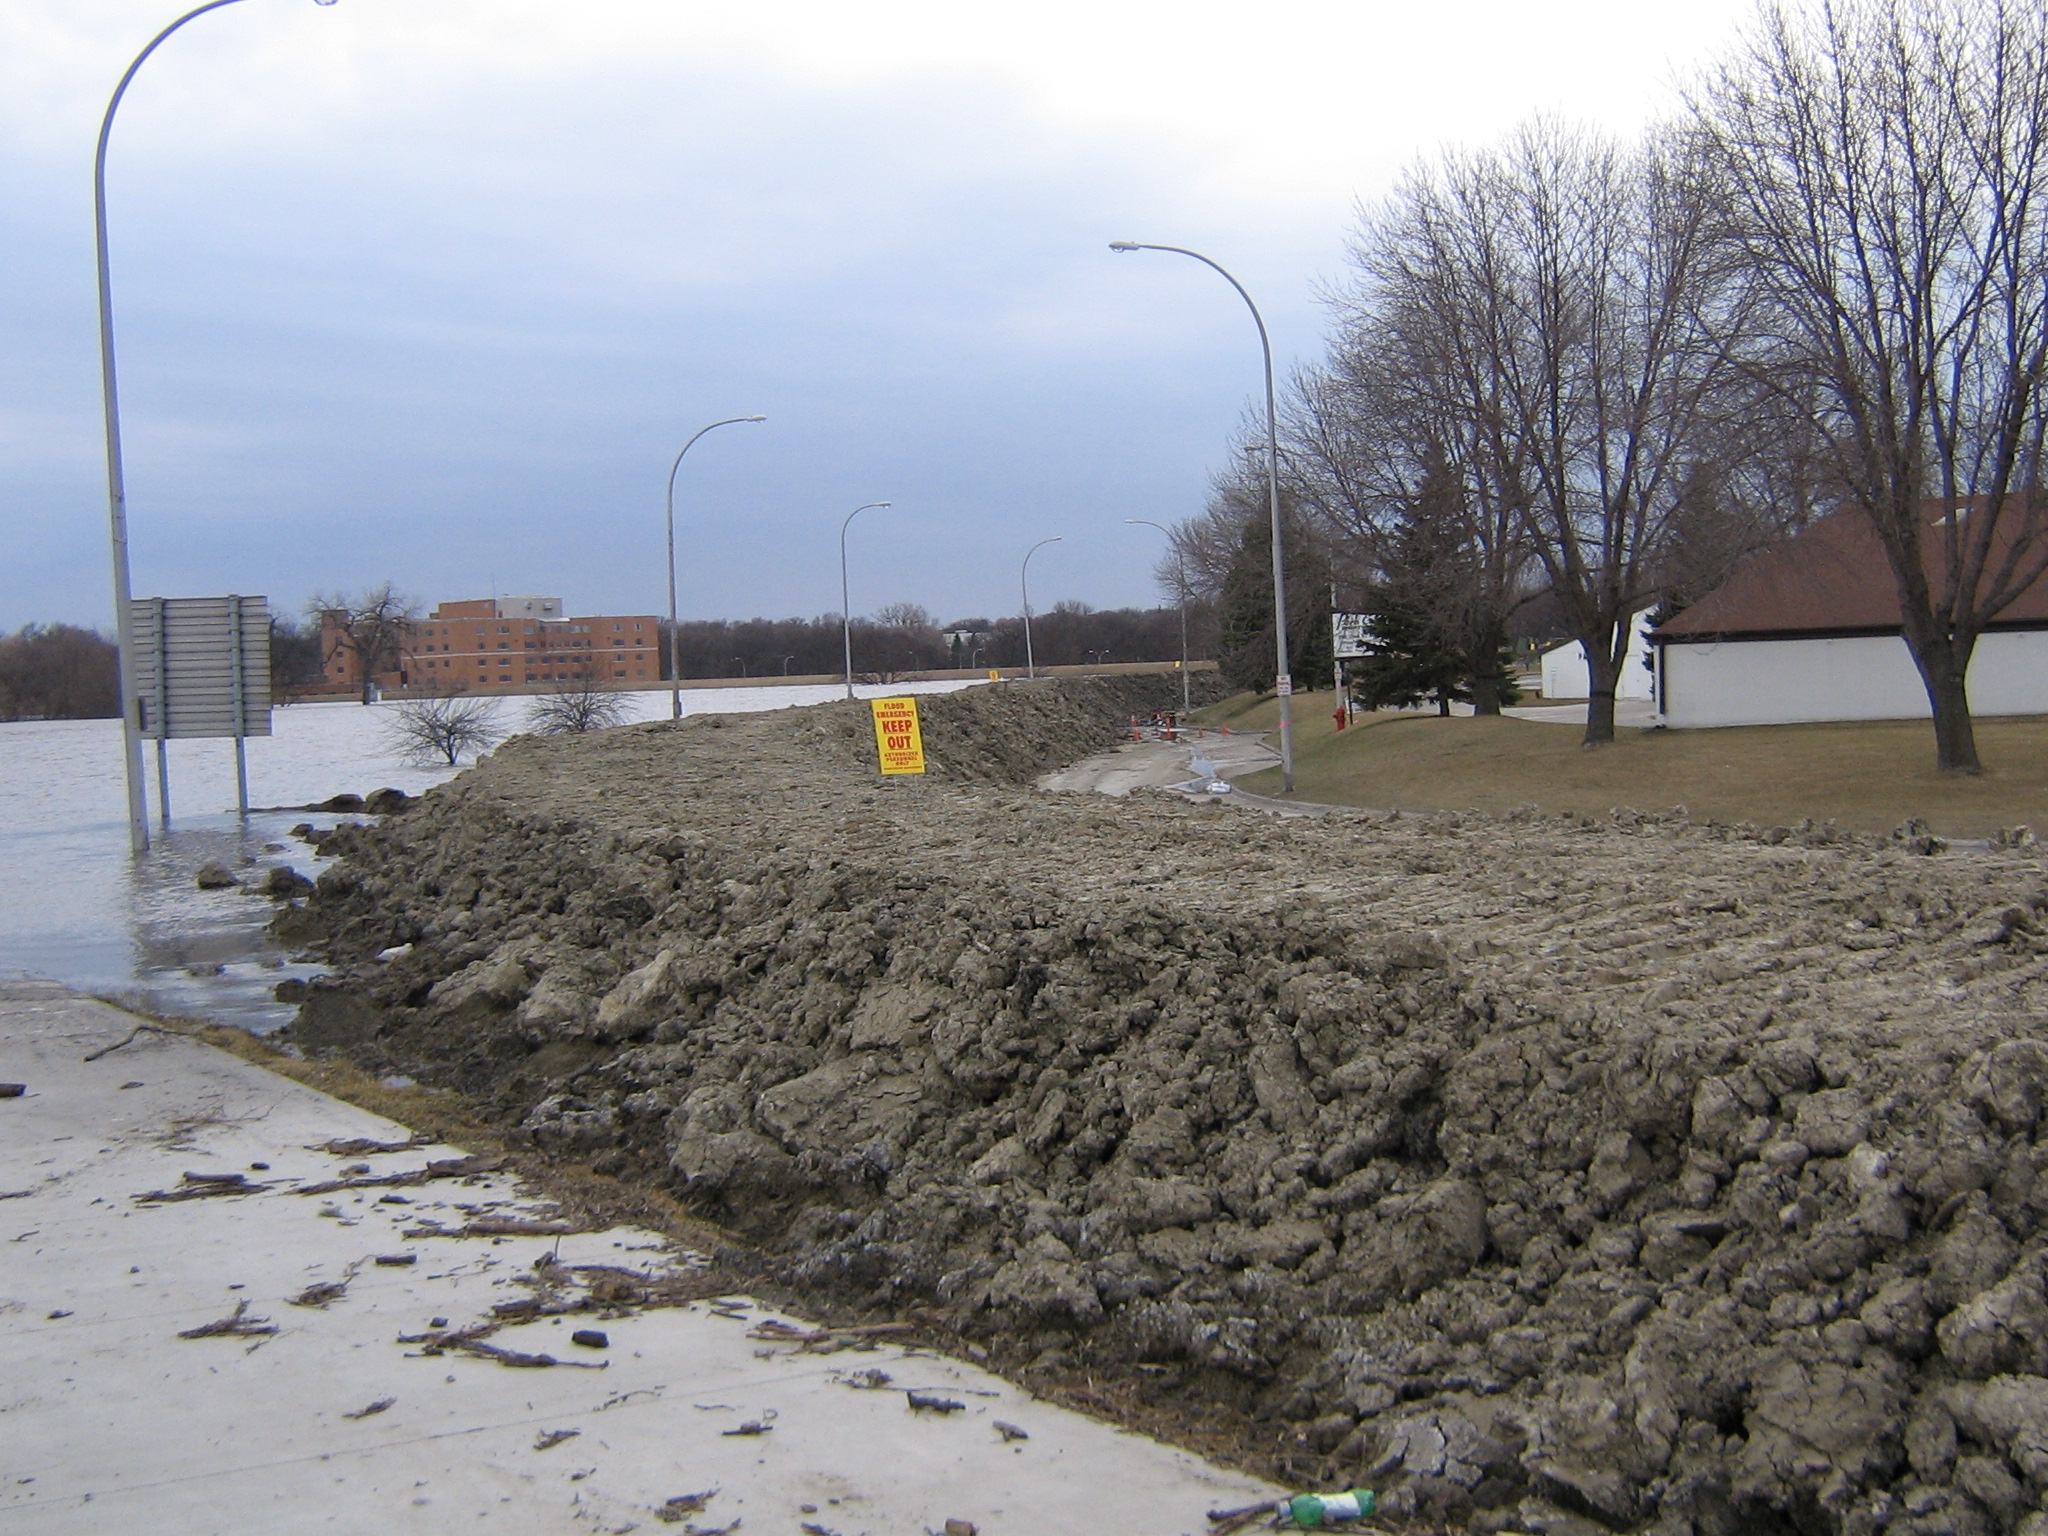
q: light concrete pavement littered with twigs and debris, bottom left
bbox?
[0,981,1278,1536]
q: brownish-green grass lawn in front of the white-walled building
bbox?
[1198,694,2048,838]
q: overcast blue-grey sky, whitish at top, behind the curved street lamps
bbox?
[0,0,1749,629]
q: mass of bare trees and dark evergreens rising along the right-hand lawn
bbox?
[1159,0,2048,770]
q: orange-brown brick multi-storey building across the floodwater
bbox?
[319,596,662,694]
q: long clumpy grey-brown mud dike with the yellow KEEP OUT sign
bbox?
[276,682,2048,1536]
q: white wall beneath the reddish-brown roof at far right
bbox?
[1661,631,2048,729]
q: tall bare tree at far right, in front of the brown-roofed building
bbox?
[1696,0,2048,772]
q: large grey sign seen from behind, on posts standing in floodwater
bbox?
[129,596,270,823]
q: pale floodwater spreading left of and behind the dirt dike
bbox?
[0,682,967,1030]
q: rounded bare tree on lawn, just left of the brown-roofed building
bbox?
[1350,123,1761,745]
